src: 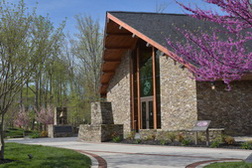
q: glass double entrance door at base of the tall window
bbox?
[141,96,153,129]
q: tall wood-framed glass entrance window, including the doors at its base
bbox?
[132,40,161,130]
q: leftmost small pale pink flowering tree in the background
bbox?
[14,107,30,129]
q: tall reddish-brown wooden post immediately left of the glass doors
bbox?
[137,47,142,129]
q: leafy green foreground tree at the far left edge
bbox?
[0,0,64,159]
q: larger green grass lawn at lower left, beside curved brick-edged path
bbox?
[0,143,91,168]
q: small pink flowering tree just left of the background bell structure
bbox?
[35,106,54,127]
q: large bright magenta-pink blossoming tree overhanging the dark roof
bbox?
[167,0,252,90]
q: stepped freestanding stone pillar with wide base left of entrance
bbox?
[78,102,123,142]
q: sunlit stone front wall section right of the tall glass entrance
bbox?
[160,56,197,130]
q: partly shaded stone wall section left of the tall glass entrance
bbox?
[107,52,131,135]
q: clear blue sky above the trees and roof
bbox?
[6,0,222,35]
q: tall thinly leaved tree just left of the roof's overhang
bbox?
[69,15,103,123]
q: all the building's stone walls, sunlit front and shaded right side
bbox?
[104,48,252,135]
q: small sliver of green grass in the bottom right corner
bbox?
[205,162,252,168]
